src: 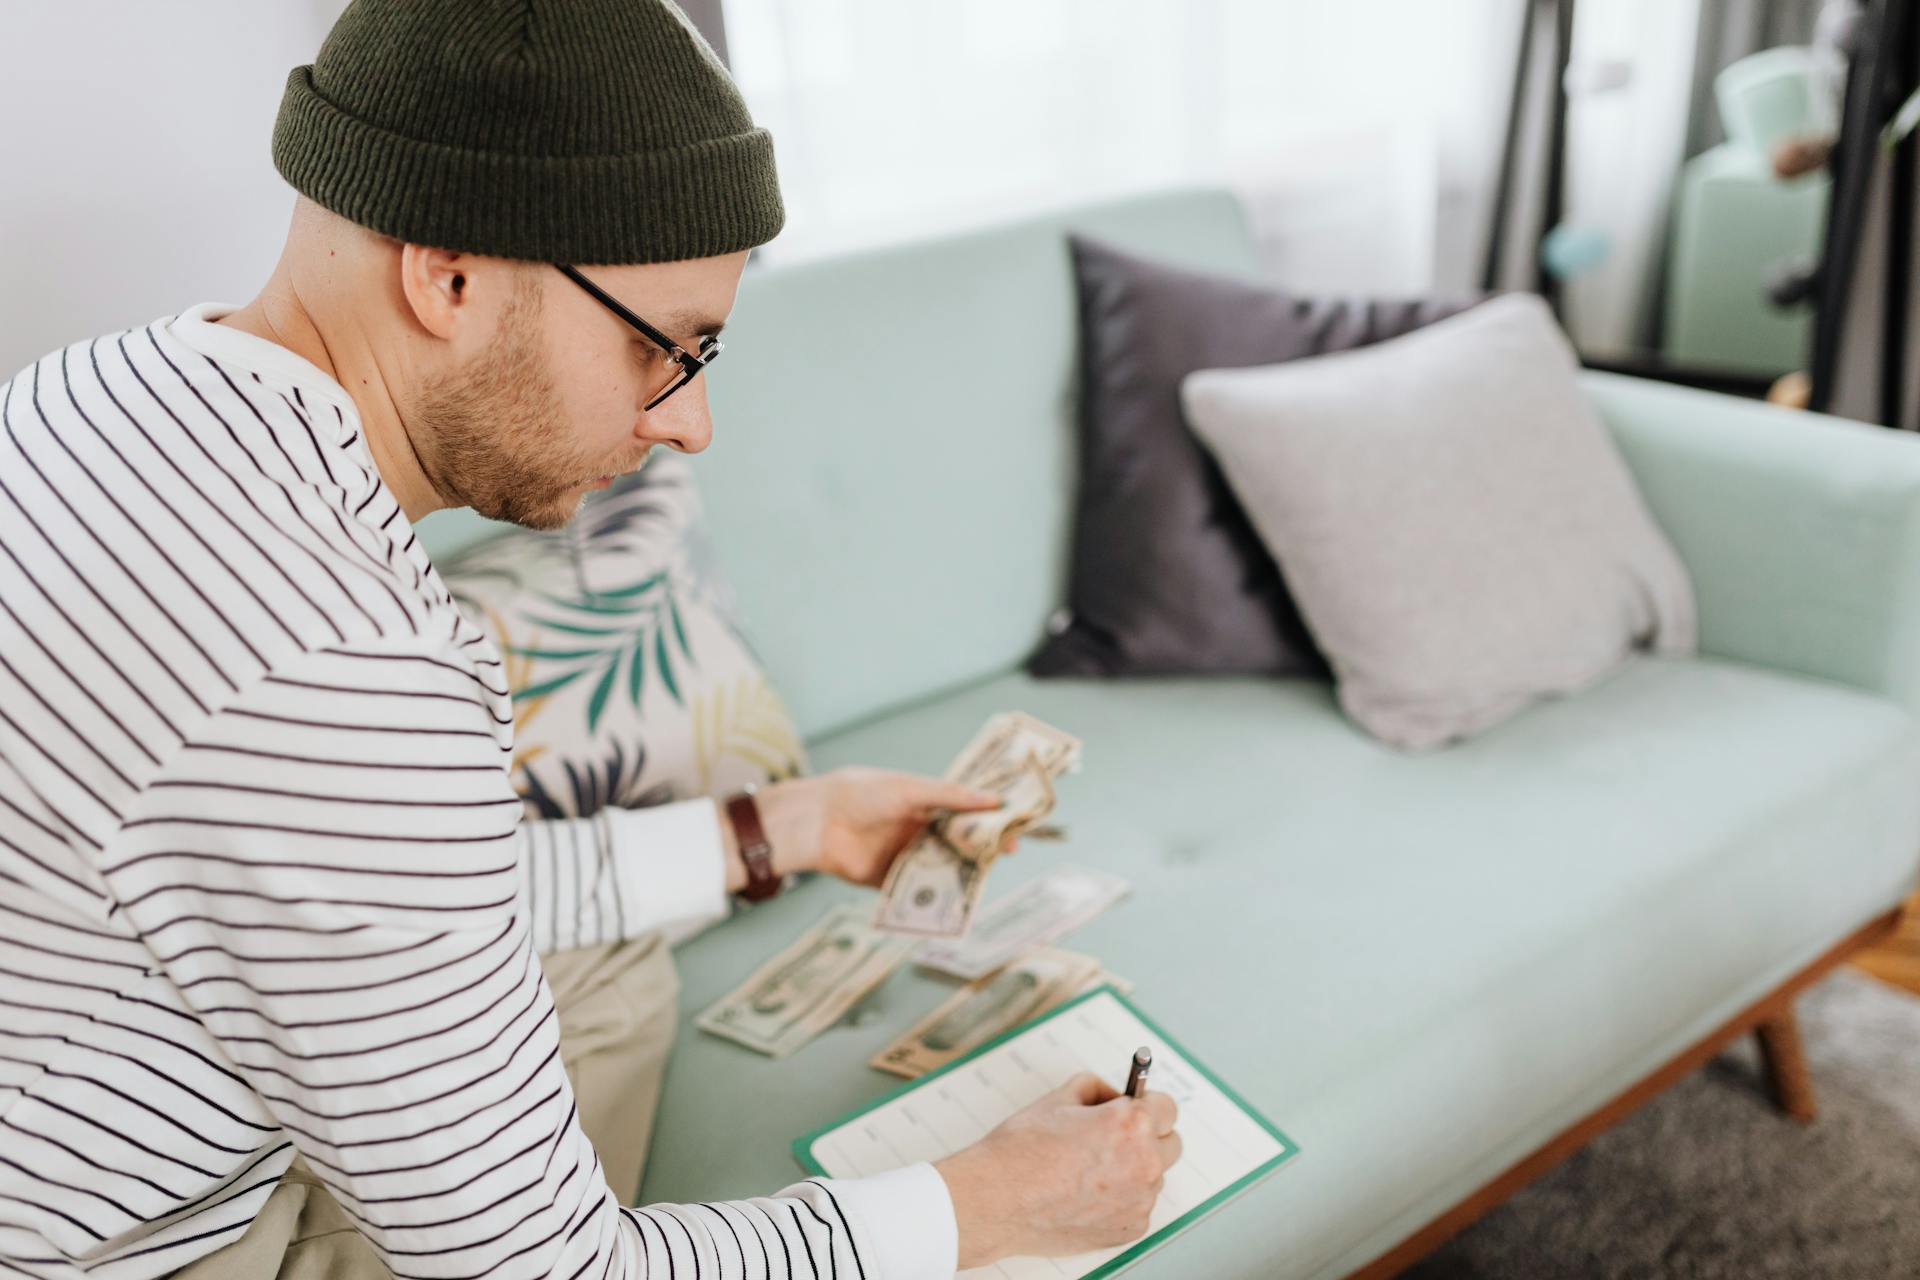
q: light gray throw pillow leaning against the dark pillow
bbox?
[1181,294,1695,748]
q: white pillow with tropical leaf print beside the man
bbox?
[442,451,806,818]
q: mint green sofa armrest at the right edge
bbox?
[1582,372,1920,710]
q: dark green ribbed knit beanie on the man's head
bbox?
[273,0,785,263]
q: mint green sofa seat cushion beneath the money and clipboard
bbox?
[645,658,1920,1276]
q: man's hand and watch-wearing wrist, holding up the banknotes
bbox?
[720,768,1018,892]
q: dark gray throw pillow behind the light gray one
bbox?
[1027,236,1476,676]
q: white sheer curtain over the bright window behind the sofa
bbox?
[724,0,1519,292]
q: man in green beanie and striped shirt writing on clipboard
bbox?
[0,0,1179,1280]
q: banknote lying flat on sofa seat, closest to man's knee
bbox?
[693,906,914,1057]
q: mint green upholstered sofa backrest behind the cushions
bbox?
[422,190,1256,739]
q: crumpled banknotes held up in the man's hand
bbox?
[874,712,1081,938]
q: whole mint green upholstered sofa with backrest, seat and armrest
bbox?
[430,190,1920,1280]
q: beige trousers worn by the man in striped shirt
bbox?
[173,935,680,1280]
